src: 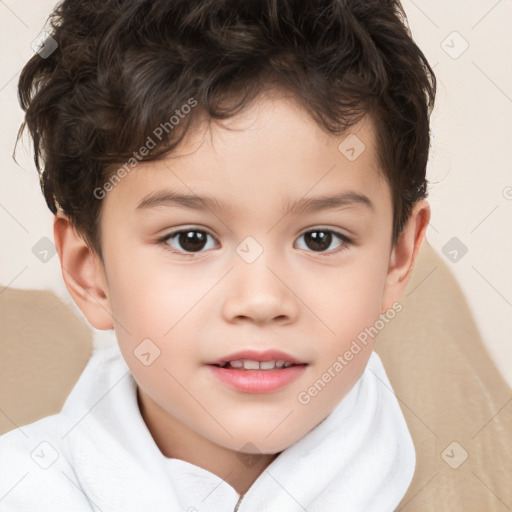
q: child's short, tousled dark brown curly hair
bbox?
[18,0,436,256]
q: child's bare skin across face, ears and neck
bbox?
[54,87,430,493]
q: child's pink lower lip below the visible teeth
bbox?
[208,365,306,393]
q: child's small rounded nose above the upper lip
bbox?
[222,255,298,325]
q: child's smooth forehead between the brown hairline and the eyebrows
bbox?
[104,91,389,220]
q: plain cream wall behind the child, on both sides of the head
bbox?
[0,0,512,386]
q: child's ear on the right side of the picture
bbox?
[382,199,430,312]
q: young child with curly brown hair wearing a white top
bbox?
[0,0,436,512]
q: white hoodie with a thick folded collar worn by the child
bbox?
[0,345,415,512]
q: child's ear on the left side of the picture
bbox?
[53,210,114,330]
